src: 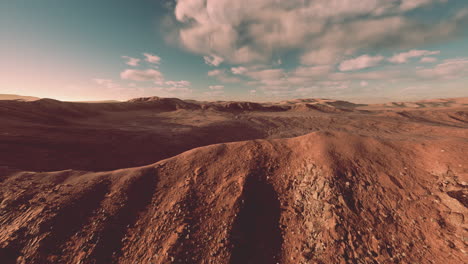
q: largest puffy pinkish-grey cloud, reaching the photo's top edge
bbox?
[173,0,467,65]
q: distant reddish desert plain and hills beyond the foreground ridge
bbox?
[0,97,468,171]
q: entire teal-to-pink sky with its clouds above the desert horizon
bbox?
[0,0,468,102]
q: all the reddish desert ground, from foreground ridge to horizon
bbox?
[0,98,468,264]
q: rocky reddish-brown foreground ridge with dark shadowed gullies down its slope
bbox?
[0,132,468,264]
